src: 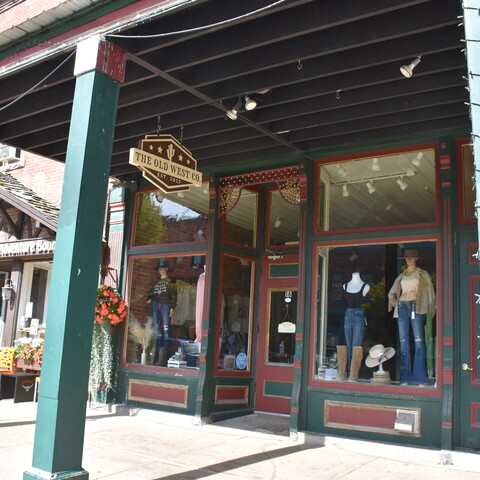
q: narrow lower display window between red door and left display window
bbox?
[217,254,255,373]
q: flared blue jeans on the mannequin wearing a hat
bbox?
[398,300,427,383]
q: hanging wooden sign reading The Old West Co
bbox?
[129,135,202,193]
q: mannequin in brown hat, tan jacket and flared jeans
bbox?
[388,250,436,385]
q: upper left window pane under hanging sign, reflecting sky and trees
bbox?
[133,184,209,246]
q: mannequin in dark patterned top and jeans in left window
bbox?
[147,259,177,365]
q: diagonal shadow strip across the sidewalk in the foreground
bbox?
[154,445,318,480]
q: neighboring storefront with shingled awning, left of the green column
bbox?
[0,173,59,345]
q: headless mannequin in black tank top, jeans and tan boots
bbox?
[337,272,370,382]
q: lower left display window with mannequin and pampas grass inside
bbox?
[124,254,205,369]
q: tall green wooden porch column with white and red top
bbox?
[23,37,125,480]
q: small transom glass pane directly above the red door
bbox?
[268,190,300,247]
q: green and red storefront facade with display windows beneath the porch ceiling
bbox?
[118,137,478,448]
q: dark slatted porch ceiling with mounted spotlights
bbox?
[0,0,469,179]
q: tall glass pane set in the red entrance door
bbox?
[268,290,297,364]
